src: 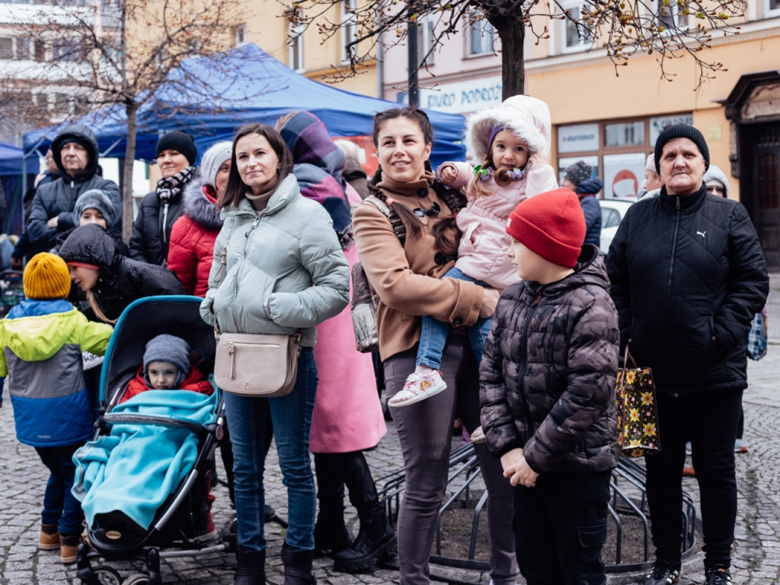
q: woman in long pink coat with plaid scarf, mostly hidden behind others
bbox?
[276,112,395,572]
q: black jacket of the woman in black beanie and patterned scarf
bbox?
[130,168,200,266]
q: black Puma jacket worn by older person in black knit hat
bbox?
[607,186,769,396]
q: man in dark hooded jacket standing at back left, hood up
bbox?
[27,124,122,250]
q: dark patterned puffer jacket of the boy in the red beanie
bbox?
[479,245,619,473]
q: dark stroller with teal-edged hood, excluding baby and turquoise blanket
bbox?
[77,296,231,585]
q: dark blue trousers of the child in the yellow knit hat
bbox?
[35,444,84,536]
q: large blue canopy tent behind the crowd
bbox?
[24,43,465,165]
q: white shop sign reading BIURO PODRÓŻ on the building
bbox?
[398,75,503,114]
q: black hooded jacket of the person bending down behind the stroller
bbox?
[60,224,185,320]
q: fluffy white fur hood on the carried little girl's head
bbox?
[466,95,552,164]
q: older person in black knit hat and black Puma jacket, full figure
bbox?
[607,125,769,585]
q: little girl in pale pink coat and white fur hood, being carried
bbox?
[388,95,558,408]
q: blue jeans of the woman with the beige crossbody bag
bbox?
[224,347,317,552]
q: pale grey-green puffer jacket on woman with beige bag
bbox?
[200,174,349,347]
